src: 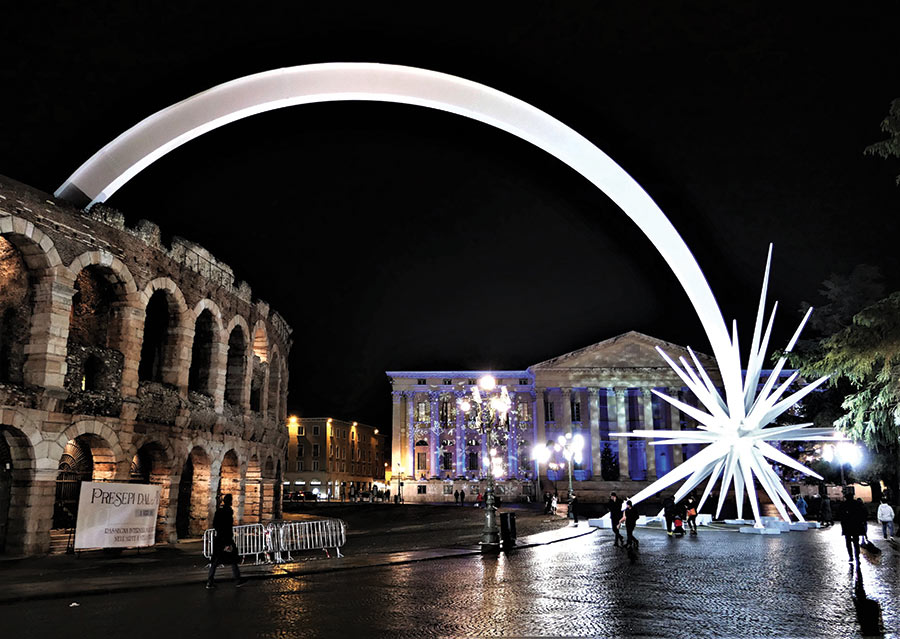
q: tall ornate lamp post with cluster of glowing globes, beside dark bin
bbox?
[457,375,512,553]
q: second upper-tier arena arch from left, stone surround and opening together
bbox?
[65,251,137,404]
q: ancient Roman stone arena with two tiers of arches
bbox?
[0,177,291,554]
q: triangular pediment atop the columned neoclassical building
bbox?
[529,331,716,374]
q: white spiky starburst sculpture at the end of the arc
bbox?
[611,245,844,527]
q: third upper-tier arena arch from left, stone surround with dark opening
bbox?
[138,277,194,390]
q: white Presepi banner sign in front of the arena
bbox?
[75,481,160,550]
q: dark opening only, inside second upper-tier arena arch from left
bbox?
[66,264,125,404]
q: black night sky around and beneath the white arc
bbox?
[0,1,900,436]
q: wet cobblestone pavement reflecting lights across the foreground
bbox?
[0,529,900,639]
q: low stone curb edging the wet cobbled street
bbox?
[0,526,597,606]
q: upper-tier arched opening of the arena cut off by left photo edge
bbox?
[0,237,34,385]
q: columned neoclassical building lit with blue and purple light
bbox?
[387,332,732,501]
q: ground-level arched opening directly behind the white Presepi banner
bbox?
[51,433,116,536]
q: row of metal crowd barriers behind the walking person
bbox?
[203,519,347,564]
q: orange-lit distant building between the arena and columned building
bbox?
[284,417,385,499]
